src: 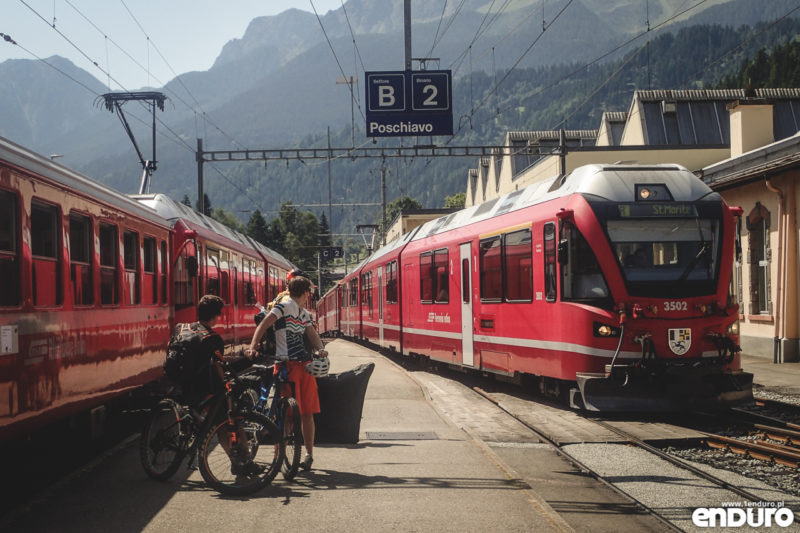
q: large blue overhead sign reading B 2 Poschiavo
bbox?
[364,70,453,137]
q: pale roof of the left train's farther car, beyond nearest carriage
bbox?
[131,194,294,268]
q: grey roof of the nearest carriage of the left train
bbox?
[0,137,170,227]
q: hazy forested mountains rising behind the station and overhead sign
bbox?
[0,0,797,236]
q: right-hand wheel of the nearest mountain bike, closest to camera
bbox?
[198,411,285,496]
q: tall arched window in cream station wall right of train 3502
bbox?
[747,202,772,315]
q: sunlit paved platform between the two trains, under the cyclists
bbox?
[0,340,665,533]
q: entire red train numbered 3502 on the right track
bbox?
[318,165,753,411]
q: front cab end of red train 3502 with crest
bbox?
[556,183,753,411]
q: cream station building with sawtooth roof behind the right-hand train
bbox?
[465,89,800,363]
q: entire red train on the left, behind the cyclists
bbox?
[0,137,292,441]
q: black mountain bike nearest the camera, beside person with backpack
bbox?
[139,362,285,495]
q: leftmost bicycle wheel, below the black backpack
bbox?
[139,399,192,481]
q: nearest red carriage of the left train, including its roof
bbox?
[0,135,172,440]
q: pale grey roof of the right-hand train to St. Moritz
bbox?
[406,164,719,244]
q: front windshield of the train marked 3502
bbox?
[606,218,720,297]
